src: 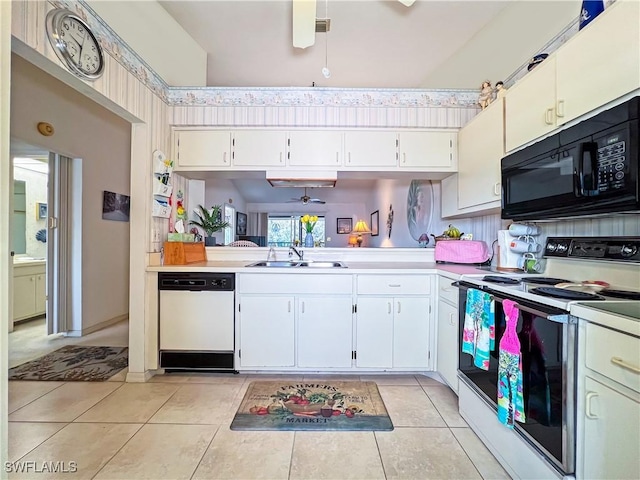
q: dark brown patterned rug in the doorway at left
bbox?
[9,345,129,382]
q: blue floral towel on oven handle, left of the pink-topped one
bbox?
[462,288,496,370]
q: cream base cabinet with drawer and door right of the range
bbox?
[576,320,640,480]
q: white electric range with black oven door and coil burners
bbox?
[458,237,640,478]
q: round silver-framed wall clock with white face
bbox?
[46,9,104,80]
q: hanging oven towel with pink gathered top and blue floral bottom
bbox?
[498,300,525,428]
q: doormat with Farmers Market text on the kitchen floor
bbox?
[231,381,393,431]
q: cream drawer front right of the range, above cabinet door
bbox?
[585,323,640,392]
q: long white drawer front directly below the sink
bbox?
[236,272,353,295]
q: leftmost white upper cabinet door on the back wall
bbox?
[175,130,231,168]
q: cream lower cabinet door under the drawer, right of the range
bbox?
[576,377,640,479]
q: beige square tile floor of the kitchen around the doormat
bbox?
[9,374,509,480]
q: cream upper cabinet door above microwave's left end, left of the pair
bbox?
[504,57,556,152]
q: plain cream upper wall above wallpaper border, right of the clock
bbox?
[87,0,207,87]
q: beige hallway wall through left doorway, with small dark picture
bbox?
[11,55,131,330]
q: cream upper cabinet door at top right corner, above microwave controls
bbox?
[557,1,640,123]
